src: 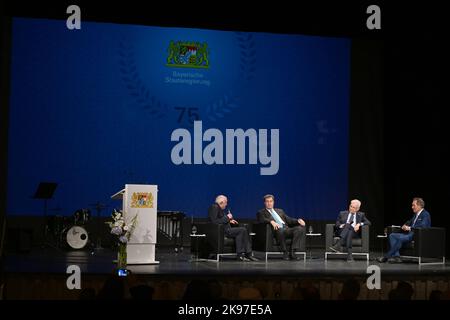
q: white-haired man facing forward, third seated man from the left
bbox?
[330,199,370,261]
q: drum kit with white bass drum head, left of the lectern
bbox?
[47,205,106,250]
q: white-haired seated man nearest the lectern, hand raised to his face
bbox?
[208,195,258,261]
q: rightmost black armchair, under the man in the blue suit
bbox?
[387,227,445,265]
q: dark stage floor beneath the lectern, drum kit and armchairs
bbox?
[3,248,450,278]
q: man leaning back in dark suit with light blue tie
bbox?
[256,194,305,260]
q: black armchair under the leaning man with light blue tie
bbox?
[252,223,306,261]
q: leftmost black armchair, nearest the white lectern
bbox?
[196,222,251,262]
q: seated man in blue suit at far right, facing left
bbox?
[377,198,431,263]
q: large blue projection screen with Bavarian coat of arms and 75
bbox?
[7,18,350,220]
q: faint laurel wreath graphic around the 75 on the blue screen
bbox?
[119,32,256,121]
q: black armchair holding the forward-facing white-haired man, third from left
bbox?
[325,223,370,261]
